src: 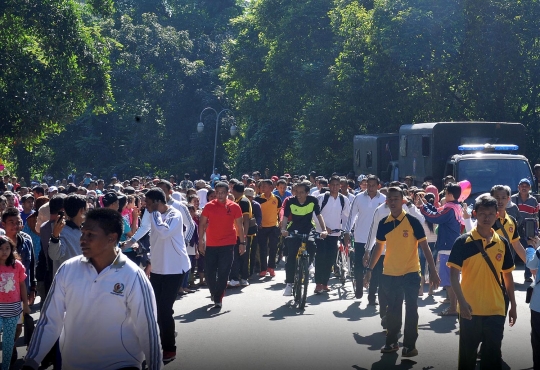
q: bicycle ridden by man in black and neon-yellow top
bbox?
[289,230,320,310]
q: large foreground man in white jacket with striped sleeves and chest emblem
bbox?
[24,208,163,370]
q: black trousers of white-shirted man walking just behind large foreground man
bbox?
[150,272,184,352]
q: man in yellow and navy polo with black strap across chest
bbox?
[450,196,517,370]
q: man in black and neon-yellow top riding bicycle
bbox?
[281,181,328,296]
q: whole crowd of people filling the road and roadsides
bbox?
[0,169,540,369]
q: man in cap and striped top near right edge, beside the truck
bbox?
[510,178,538,283]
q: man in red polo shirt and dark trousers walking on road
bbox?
[199,182,247,308]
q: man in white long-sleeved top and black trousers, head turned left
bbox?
[146,187,191,363]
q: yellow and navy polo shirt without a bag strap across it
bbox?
[377,210,426,276]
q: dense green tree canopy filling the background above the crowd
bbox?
[0,0,540,176]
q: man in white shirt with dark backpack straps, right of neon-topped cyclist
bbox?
[315,176,351,294]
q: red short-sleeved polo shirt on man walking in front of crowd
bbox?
[202,199,242,247]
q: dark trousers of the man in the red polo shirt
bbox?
[204,245,234,303]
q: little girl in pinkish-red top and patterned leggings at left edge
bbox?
[0,235,30,370]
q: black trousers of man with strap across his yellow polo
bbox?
[458,315,505,370]
